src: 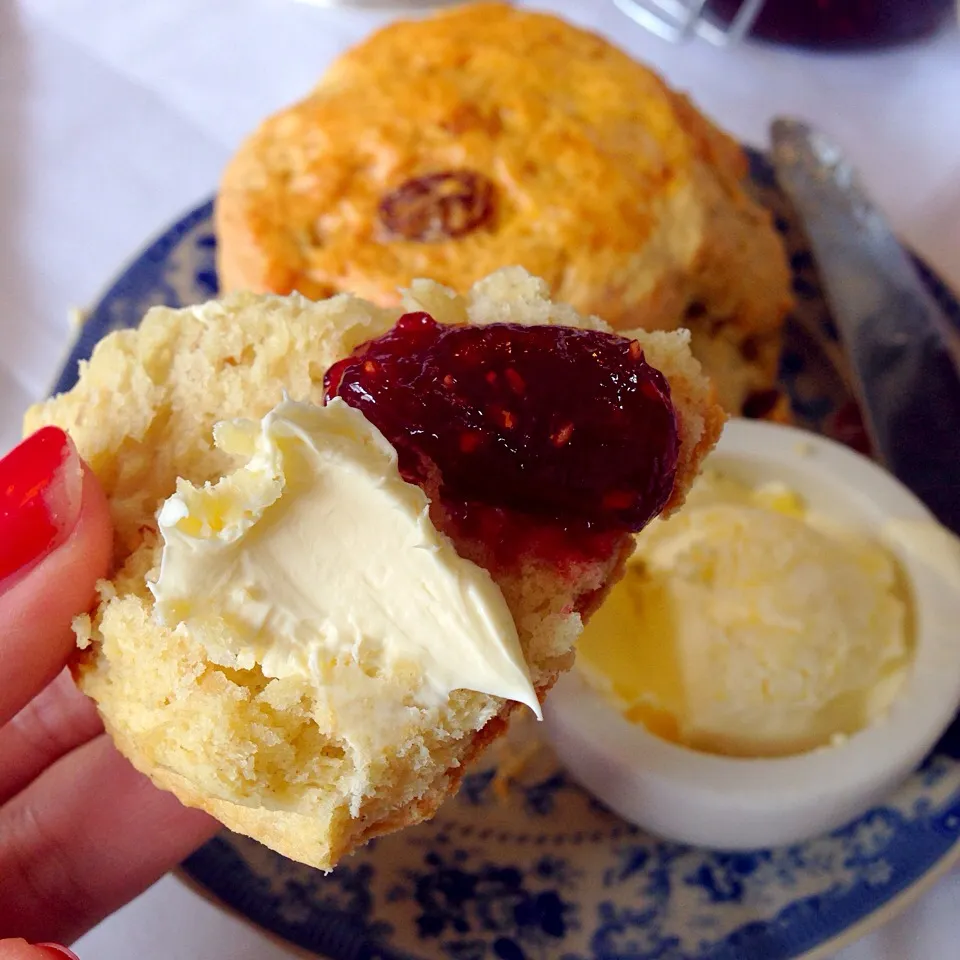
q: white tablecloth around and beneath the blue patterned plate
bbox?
[0,0,960,960]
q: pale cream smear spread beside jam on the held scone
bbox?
[148,399,540,722]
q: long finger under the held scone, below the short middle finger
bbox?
[0,734,218,943]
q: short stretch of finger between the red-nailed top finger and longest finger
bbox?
[0,670,103,808]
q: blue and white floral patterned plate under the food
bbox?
[57,155,960,960]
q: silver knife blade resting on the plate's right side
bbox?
[770,118,960,533]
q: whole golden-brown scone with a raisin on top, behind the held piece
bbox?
[216,3,790,416]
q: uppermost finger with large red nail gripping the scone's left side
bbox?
[0,427,112,726]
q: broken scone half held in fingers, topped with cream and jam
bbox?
[26,268,723,869]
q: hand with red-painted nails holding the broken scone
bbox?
[0,427,216,948]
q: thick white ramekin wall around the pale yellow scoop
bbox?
[545,420,960,849]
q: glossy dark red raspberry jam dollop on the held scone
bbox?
[324,313,678,536]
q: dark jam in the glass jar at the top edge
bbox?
[706,0,956,50]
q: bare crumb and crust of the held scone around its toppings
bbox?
[25,269,723,869]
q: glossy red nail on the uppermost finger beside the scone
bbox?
[0,427,83,587]
